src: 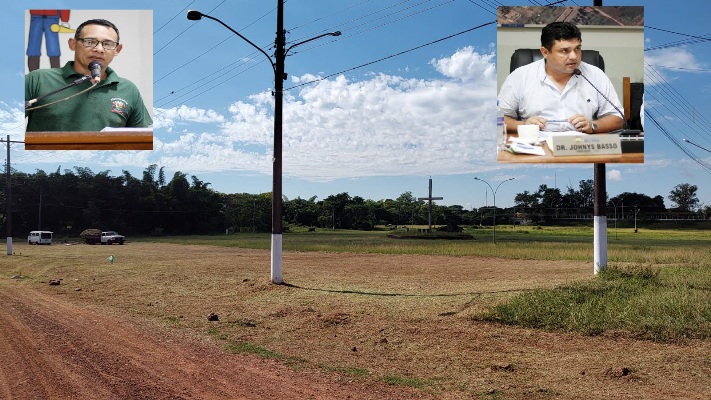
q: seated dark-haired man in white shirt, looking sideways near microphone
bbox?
[499,22,623,133]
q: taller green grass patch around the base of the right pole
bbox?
[474,265,711,343]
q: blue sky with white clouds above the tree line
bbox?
[0,0,711,212]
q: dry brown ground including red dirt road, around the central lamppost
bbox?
[0,243,711,399]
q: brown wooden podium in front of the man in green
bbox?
[25,128,153,150]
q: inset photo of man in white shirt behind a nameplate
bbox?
[495,6,644,163]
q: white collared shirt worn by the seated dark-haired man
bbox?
[499,59,622,130]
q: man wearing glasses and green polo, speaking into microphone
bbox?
[25,19,153,132]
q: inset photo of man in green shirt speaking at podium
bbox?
[25,9,153,150]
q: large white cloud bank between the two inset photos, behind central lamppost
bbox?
[147,47,496,181]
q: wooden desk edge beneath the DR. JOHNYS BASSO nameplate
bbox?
[496,135,644,164]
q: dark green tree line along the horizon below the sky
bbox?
[0,164,711,237]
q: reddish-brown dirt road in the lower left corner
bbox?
[0,286,434,400]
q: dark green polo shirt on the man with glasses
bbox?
[25,61,153,132]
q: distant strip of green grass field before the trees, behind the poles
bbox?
[139,226,711,265]
